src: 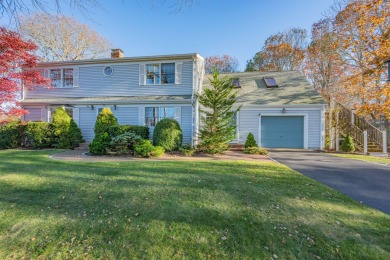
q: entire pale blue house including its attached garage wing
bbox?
[21,49,325,149]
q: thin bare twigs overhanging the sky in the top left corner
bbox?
[0,0,99,24]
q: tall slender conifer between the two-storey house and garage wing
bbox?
[197,71,240,154]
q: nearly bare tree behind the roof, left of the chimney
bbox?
[20,14,111,61]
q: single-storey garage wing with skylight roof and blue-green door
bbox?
[203,71,326,149]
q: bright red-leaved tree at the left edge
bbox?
[0,27,50,122]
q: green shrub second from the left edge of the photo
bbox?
[22,122,53,149]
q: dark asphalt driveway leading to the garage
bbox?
[269,149,390,214]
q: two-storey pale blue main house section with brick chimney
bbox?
[21,49,204,144]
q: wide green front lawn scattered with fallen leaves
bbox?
[0,150,390,259]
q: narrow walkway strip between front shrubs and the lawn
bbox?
[50,149,272,162]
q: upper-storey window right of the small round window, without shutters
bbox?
[146,63,175,85]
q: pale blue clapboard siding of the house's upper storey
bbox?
[25,61,193,98]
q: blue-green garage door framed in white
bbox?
[261,116,303,148]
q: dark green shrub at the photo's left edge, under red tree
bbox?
[0,121,26,149]
